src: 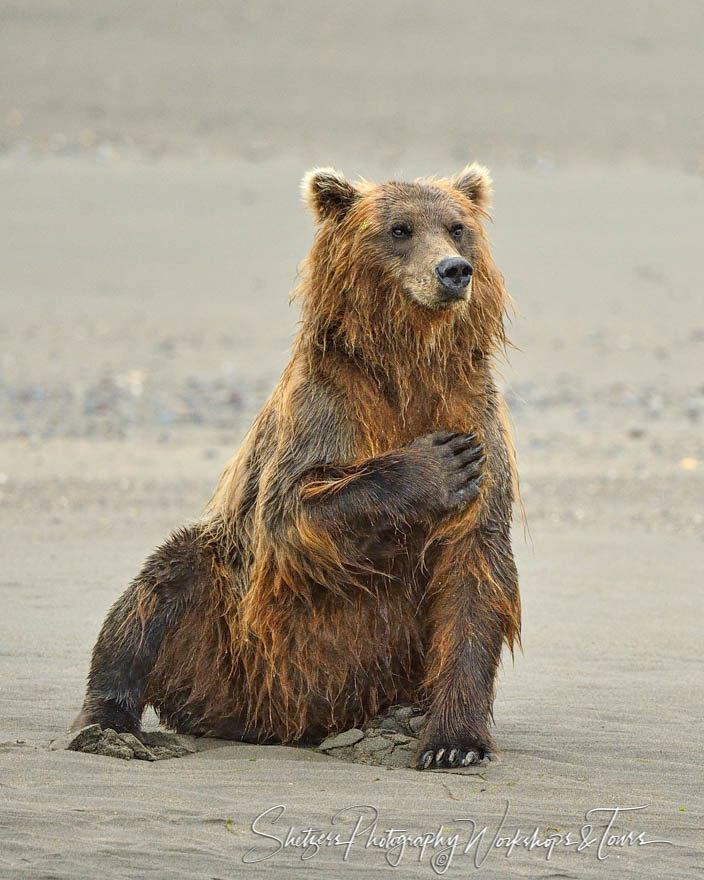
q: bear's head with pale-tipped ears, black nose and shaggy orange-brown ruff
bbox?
[299,164,507,372]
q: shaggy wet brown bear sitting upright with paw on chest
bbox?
[74,164,520,769]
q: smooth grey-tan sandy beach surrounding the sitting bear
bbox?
[0,0,704,880]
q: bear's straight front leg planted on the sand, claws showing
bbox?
[416,530,520,770]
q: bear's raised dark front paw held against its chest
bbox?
[411,431,486,515]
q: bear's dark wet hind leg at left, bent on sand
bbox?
[71,525,213,733]
